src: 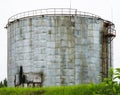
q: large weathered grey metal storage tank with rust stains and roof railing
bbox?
[6,8,115,86]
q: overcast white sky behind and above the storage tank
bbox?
[0,0,120,81]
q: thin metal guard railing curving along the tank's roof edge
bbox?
[8,8,100,23]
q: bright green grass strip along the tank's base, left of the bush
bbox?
[0,84,95,95]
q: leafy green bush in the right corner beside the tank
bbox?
[94,68,120,95]
